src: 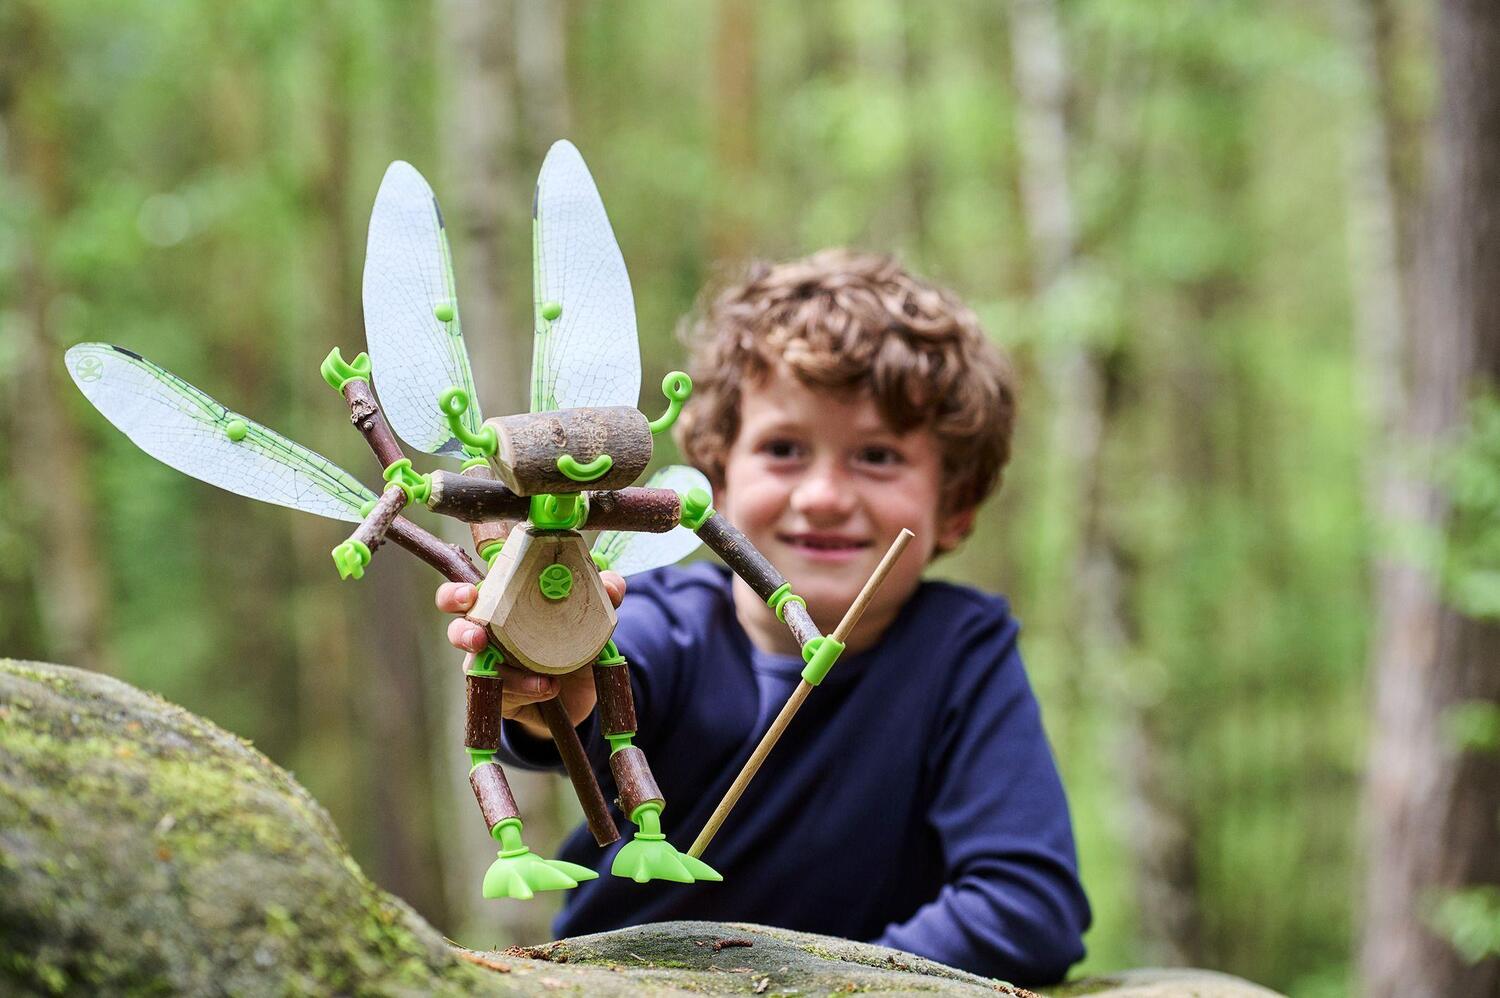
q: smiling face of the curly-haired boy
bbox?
[714,371,974,645]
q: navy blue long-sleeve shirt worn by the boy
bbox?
[503,563,1089,984]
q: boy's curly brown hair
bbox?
[677,249,1016,513]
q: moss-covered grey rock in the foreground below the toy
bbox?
[0,659,1268,996]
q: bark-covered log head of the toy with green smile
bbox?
[485,405,651,495]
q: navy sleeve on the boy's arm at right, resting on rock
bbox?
[876,615,1091,984]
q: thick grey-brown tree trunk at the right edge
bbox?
[1362,0,1500,998]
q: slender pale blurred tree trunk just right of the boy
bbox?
[1011,0,1200,965]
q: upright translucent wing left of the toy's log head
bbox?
[365,159,485,456]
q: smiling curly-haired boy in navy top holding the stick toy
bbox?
[438,251,1089,984]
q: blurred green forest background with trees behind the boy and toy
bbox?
[0,0,1500,996]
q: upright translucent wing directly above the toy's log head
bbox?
[531,141,641,413]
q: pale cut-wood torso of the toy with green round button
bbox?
[468,522,615,675]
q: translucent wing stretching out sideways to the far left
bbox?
[66,344,375,522]
